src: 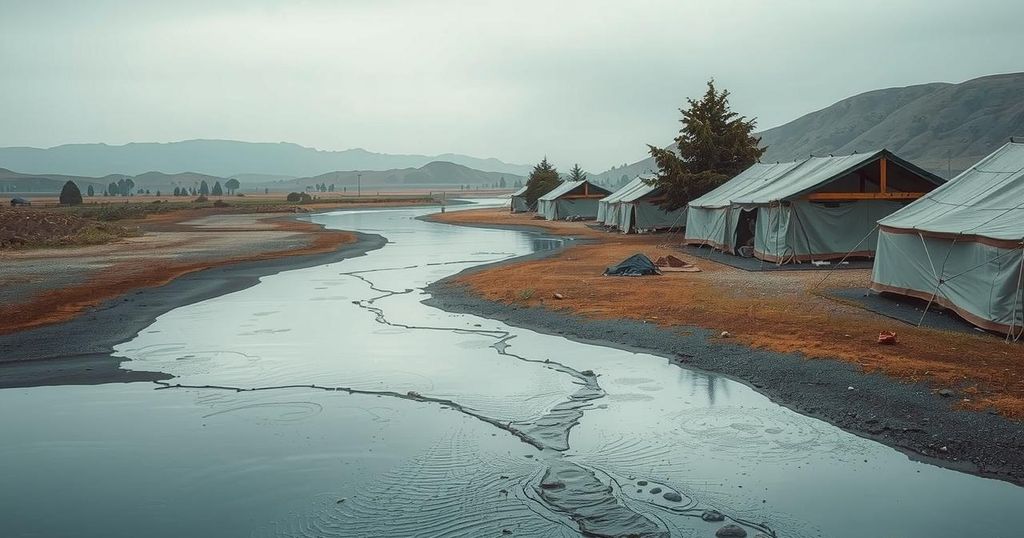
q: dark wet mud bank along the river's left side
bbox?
[0,228,387,388]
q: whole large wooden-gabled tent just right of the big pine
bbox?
[685,150,943,263]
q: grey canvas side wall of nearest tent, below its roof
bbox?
[871,230,1024,333]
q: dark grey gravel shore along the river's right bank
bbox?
[424,258,1024,485]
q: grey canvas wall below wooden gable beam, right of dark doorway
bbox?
[753,200,903,262]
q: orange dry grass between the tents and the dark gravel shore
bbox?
[438,210,1024,418]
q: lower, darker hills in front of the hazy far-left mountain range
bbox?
[0,161,524,194]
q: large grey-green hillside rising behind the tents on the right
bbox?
[593,73,1024,183]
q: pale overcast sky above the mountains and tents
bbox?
[0,0,1024,171]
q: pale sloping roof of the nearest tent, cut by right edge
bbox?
[879,141,1024,241]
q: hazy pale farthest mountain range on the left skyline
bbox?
[0,140,530,180]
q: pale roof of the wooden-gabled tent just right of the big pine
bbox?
[689,150,943,208]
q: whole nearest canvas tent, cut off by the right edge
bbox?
[871,140,1024,339]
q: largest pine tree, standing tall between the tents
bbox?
[647,80,766,210]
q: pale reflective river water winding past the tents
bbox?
[0,202,1024,537]
